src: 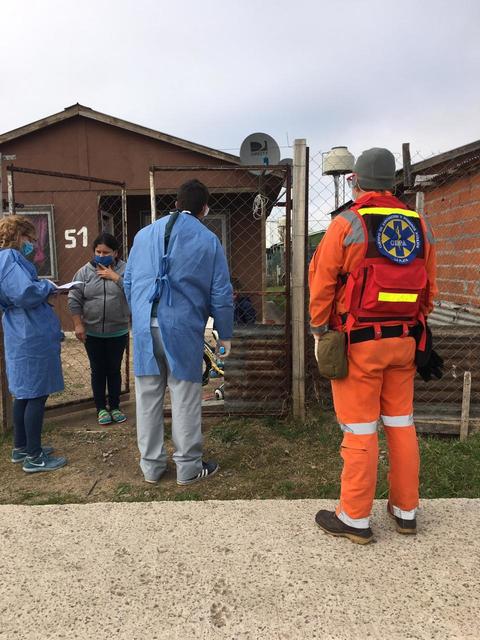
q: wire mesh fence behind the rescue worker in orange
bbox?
[307,143,480,432]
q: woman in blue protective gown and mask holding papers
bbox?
[0,215,67,473]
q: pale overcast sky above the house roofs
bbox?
[0,0,480,157]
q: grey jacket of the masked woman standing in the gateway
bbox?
[68,260,130,334]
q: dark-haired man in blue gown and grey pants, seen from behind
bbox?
[124,180,233,485]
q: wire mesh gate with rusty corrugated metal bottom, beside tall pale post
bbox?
[150,165,291,415]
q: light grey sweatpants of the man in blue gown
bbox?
[135,327,202,480]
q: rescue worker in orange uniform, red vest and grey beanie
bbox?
[309,148,436,544]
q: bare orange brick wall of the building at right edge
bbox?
[425,172,480,306]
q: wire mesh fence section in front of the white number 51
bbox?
[4,165,130,409]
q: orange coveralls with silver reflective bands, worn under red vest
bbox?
[309,192,437,528]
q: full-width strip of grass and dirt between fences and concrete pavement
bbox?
[0,410,480,505]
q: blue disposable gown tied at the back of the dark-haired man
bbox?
[124,213,233,382]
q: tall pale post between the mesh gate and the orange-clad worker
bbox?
[291,138,307,420]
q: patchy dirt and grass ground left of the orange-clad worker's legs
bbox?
[0,402,341,504]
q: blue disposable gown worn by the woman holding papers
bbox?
[0,249,63,399]
